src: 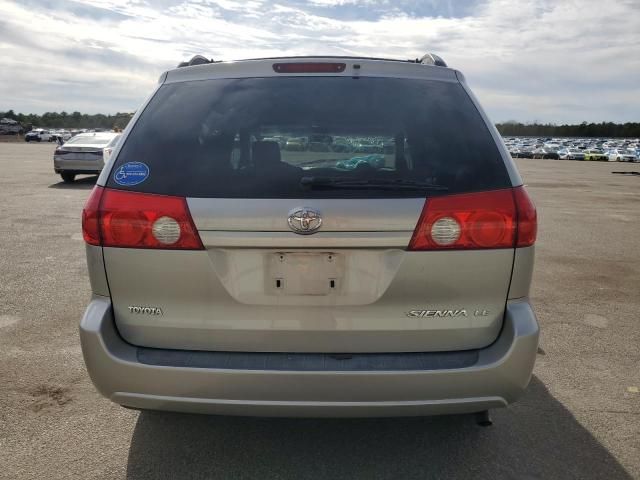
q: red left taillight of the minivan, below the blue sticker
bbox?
[82,187,203,250]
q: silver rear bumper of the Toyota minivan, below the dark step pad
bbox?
[80,297,539,417]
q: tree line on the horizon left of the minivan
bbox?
[0,110,133,130]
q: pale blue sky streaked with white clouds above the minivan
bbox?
[0,0,640,123]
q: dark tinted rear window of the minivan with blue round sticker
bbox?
[107,77,510,198]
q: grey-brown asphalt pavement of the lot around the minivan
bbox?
[0,143,640,480]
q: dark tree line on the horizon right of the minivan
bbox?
[496,122,640,137]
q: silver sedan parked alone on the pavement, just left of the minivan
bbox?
[53,132,120,182]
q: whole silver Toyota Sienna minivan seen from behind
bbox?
[80,55,539,417]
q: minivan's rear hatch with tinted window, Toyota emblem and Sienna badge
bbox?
[104,67,514,352]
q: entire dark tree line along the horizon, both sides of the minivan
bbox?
[0,110,640,137]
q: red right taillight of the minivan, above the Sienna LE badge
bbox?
[408,187,536,250]
